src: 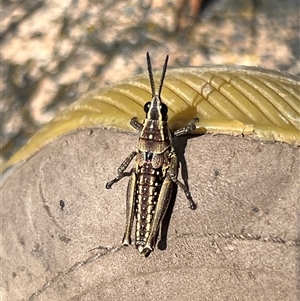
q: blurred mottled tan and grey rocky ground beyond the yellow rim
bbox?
[0,0,300,163]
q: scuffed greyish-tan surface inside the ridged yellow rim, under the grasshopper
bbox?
[0,129,300,301]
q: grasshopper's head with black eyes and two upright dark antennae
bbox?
[144,52,169,121]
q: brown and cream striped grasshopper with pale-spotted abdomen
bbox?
[106,52,198,257]
